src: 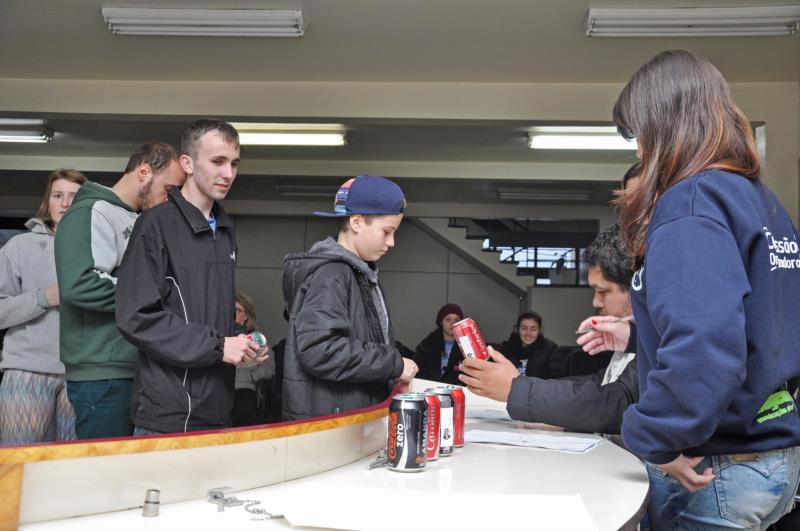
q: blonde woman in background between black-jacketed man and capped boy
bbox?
[233,293,275,427]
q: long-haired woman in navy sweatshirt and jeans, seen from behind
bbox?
[613,50,800,529]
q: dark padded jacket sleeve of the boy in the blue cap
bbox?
[294,277,403,382]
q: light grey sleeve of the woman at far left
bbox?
[0,240,50,329]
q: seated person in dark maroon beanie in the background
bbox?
[414,303,464,385]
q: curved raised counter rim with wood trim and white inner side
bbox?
[0,386,407,530]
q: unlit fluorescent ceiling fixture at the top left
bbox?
[103,7,305,37]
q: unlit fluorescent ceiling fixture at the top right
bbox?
[586,5,800,37]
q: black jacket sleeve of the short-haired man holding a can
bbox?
[116,218,225,368]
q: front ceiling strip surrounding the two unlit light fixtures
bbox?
[0,0,800,83]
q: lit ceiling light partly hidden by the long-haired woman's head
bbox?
[528,126,636,151]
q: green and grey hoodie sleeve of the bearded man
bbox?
[55,204,117,312]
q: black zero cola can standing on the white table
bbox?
[386,393,428,472]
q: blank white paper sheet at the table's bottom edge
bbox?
[264,484,597,531]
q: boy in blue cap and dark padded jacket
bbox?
[283,175,417,419]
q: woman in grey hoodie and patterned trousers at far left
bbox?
[0,169,86,444]
